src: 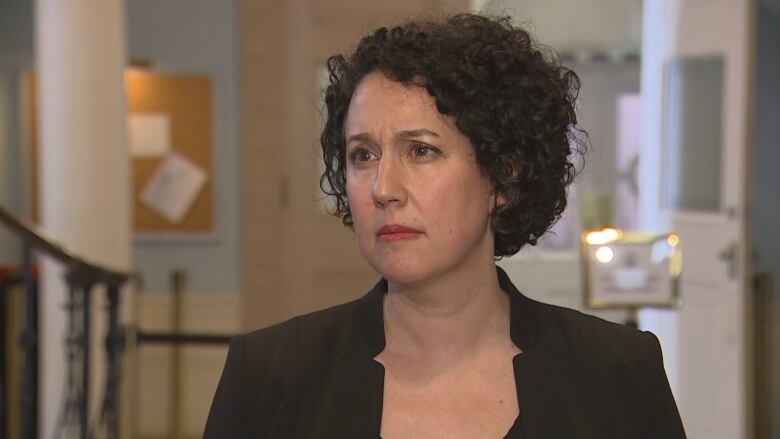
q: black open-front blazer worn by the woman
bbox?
[204,268,685,439]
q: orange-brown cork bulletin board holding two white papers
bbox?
[125,71,214,234]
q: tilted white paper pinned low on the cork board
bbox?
[141,153,208,223]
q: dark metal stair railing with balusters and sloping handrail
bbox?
[0,207,129,439]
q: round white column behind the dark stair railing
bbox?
[35,0,131,439]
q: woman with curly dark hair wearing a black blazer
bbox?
[204,14,685,439]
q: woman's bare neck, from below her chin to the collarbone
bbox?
[384,261,511,365]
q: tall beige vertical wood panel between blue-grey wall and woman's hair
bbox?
[238,1,287,328]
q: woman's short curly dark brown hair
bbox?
[320,14,587,258]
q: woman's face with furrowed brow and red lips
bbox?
[345,73,493,285]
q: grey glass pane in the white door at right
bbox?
[662,56,723,211]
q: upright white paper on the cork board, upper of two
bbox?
[127,113,171,158]
